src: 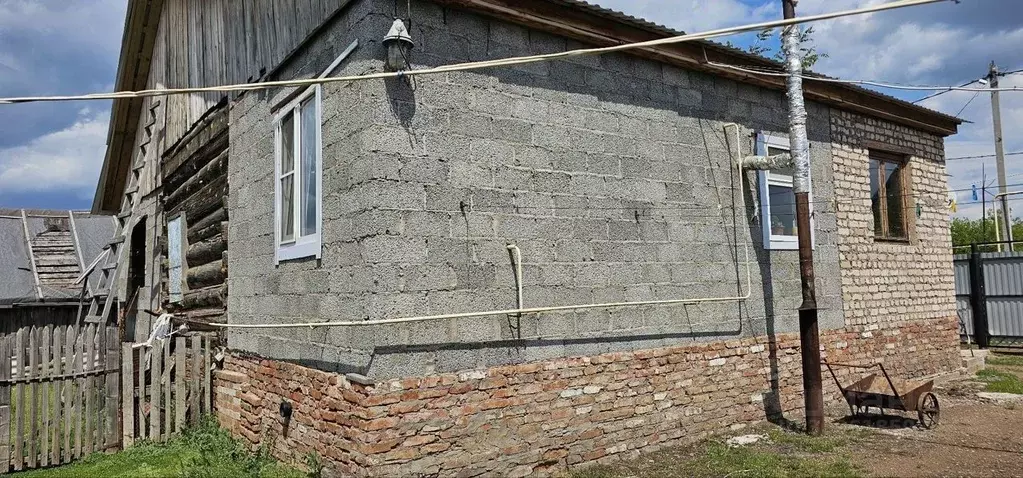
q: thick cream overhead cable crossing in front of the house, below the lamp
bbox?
[0,0,949,103]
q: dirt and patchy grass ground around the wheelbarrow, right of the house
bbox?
[570,355,1023,478]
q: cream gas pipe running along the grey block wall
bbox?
[210,123,753,329]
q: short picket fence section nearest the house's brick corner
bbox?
[121,336,213,447]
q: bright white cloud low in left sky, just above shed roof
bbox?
[0,110,109,198]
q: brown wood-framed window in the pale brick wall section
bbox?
[870,150,909,241]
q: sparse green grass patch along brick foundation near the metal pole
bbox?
[570,429,863,478]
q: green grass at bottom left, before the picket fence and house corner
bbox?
[11,419,307,478]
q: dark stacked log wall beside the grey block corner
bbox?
[161,101,228,330]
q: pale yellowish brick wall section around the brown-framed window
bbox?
[832,110,955,325]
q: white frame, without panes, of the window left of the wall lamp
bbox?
[273,85,323,264]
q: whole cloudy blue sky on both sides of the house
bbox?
[0,0,1023,217]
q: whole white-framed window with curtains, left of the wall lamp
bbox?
[274,86,322,263]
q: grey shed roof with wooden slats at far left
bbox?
[0,209,115,305]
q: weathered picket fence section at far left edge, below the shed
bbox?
[0,323,120,473]
